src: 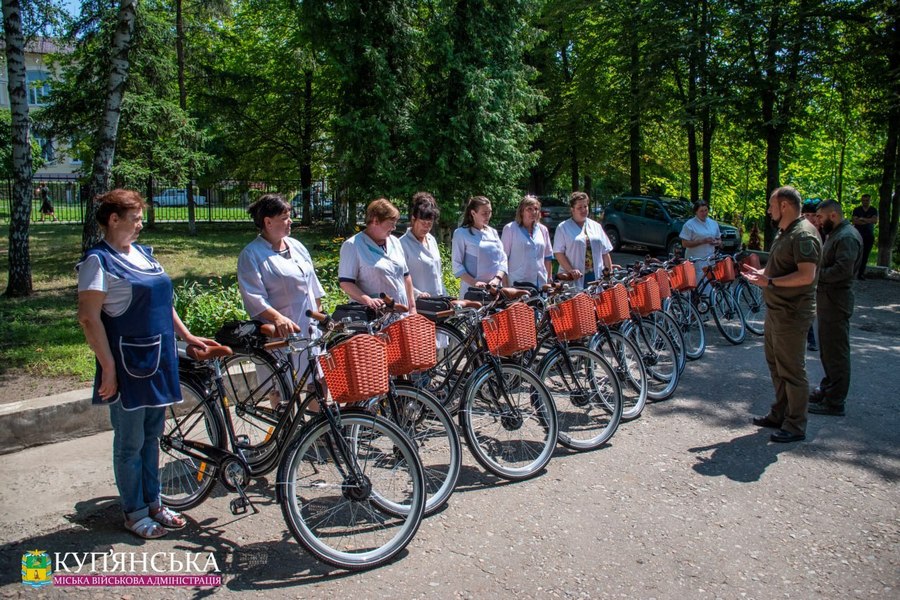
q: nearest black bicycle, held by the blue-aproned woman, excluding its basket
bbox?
[160,336,425,570]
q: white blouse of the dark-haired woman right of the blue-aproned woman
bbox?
[237,236,325,337]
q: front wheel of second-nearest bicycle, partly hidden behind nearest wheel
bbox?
[382,383,462,516]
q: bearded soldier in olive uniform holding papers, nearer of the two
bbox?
[744,186,822,442]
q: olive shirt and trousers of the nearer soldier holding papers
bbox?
[763,217,822,434]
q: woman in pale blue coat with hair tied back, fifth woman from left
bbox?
[450,196,508,298]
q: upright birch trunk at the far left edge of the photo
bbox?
[3,0,33,298]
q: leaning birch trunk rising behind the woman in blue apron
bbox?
[81,0,137,250]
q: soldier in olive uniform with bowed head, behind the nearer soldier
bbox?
[809,200,863,416]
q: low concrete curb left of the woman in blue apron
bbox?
[0,388,112,454]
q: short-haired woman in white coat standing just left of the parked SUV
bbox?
[553,192,612,289]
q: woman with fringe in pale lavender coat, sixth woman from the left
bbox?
[500,196,553,289]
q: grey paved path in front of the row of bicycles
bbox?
[0,311,900,599]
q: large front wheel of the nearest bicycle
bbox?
[278,411,425,570]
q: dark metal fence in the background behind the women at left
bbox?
[0,175,333,224]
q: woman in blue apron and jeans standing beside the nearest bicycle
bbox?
[76,189,215,539]
